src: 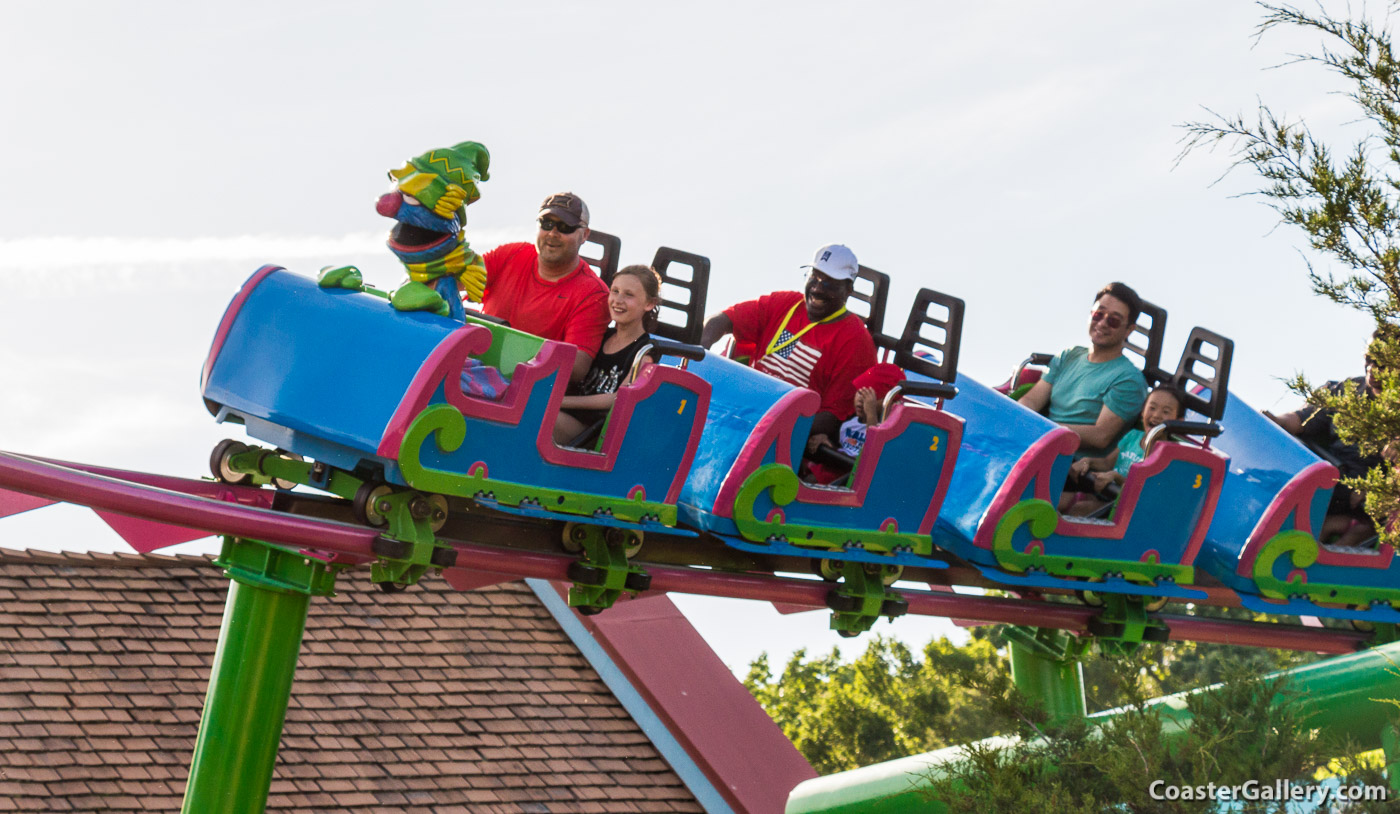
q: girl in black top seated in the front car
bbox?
[554,266,661,444]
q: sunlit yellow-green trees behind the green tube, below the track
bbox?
[743,619,1316,775]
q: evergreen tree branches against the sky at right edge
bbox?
[1183,4,1400,544]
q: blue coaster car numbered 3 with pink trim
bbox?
[934,320,1229,598]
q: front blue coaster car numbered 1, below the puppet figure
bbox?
[203,266,710,525]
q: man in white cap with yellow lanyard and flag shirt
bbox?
[700,244,875,446]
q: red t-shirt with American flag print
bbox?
[725,291,875,419]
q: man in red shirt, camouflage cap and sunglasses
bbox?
[482,192,608,380]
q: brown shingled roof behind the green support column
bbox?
[0,549,703,814]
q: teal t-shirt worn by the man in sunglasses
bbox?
[1044,346,1147,455]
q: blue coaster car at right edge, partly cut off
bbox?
[1201,395,1400,623]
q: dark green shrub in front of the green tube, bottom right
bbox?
[925,663,1389,814]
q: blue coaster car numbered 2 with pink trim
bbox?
[680,291,962,567]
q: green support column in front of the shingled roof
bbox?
[181,538,336,814]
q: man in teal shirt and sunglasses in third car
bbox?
[1021,283,1147,457]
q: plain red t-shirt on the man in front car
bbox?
[482,242,608,356]
